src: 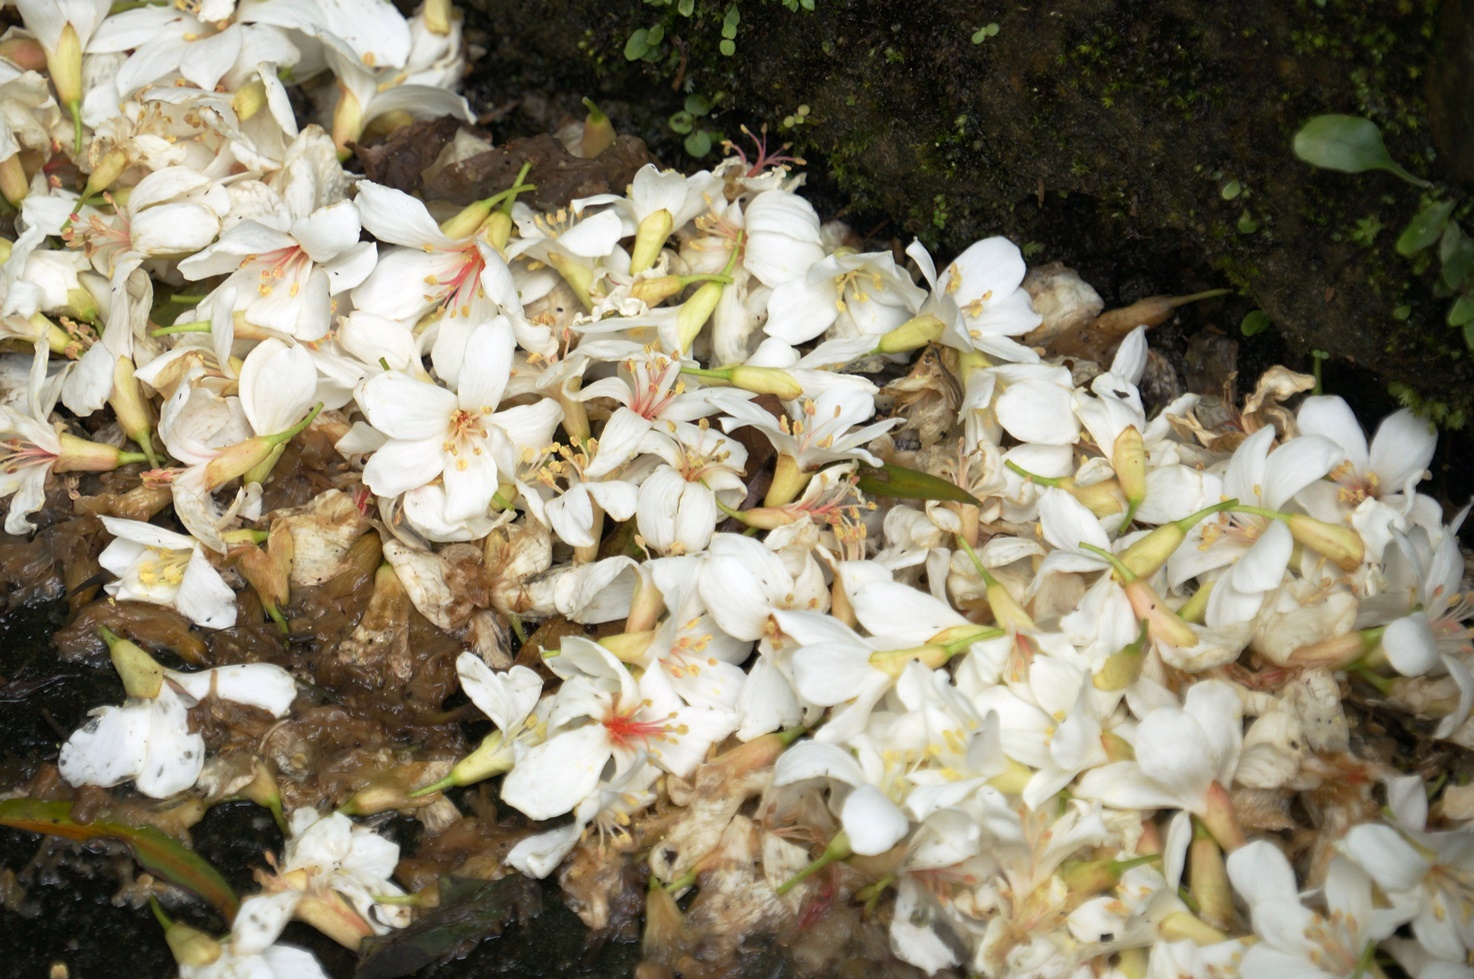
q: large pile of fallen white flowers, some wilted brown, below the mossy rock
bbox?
[0,0,1474,976]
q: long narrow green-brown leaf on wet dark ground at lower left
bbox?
[0,799,240,921]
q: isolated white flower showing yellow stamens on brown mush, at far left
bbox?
[97,516,236,630]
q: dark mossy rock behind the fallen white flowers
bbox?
[470,0,1474,425]
